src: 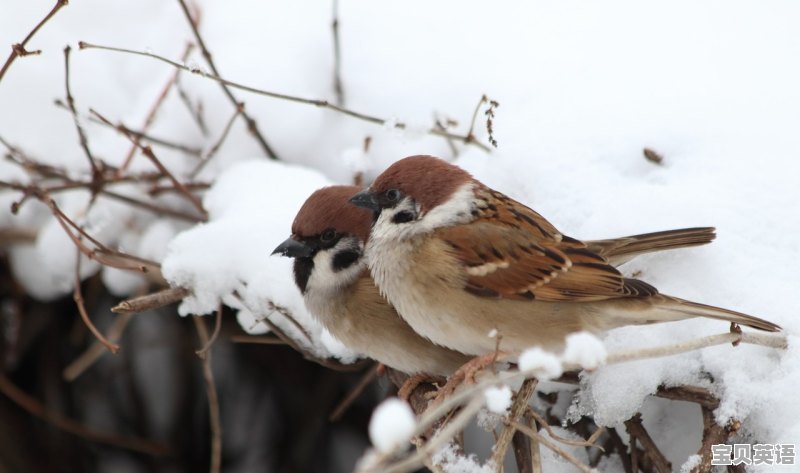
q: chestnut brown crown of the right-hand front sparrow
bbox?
[369,155,475,213]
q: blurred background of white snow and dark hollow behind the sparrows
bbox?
[0,0,800,473]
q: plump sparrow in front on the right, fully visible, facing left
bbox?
[350,156,780,356]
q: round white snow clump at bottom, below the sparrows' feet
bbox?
[369,398,417,453]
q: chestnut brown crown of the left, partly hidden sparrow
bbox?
[292,186,372,242]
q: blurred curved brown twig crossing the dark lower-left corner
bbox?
[0,371,170,456]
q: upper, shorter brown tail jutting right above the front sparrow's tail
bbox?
[586,227,717,266]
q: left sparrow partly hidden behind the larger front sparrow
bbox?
[273,186,471,376]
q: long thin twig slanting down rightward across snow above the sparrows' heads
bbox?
[79,41,491,153]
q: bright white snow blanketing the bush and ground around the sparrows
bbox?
[0,0,800,471]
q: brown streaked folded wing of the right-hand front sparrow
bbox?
[436,186,658,301]
